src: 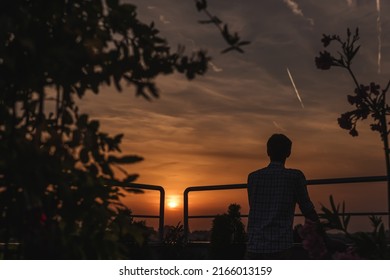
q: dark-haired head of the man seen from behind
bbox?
[267,134,292,162]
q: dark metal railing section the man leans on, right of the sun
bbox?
[183,176,390,241]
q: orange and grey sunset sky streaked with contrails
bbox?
[80,0,390,232]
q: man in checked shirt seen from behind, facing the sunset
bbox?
[247,134,318,259]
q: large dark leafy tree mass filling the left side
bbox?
[0,0,215,259]
